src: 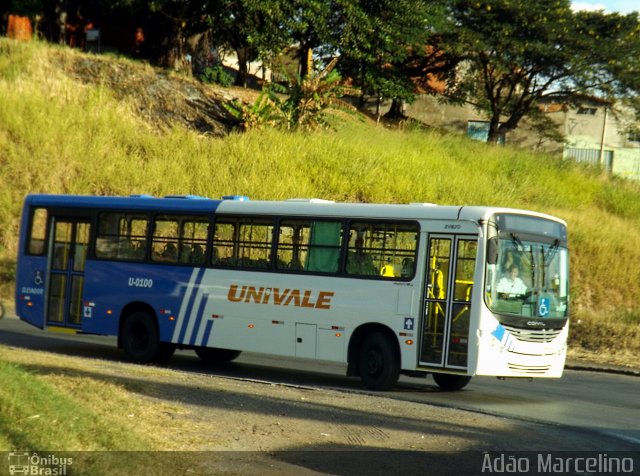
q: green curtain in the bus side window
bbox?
[305,222,342,273]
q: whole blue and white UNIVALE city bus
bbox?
[16,195,569,390]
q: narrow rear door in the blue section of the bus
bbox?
[46,217,90,328]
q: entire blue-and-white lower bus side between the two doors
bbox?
[82,261,420,369]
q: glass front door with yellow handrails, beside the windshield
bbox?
[420,235,477,371]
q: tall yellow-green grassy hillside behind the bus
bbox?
[0,39,640,360]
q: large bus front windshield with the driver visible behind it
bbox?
[485,216,569,325]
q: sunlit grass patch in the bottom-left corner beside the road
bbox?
[0,346,199,476]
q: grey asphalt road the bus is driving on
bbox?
[0,318,640,451]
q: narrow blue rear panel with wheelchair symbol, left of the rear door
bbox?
[15,255,47,329]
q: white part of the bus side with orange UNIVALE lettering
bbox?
[172,269,419,368]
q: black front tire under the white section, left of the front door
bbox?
[358,332,400,390]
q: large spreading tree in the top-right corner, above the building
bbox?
[442,0,640,143]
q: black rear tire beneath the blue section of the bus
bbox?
[122,311,175,364]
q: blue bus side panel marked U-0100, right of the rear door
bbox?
[82,261,192,342]
